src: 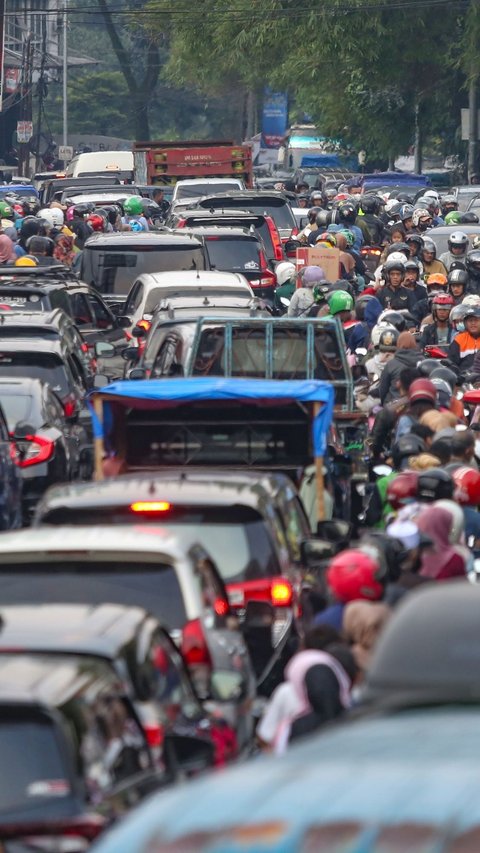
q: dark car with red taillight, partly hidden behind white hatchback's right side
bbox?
[176,225,277,303]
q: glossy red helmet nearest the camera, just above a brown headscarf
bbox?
[326,548,384,603]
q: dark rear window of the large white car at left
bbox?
[0,564,186,628]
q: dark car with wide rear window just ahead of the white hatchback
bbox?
[80,232,206,299]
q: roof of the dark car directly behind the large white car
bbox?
[0,604,150,658]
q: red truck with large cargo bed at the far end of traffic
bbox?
[133,140,253,188]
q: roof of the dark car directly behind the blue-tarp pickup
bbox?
[35,468,293,512]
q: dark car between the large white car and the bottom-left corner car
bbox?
[0,604,221,770]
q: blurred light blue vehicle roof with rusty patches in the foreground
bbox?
[92,705,480,853]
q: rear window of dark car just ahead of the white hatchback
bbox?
[80,245,205,295]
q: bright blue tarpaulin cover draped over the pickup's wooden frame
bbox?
[90,376,335,456]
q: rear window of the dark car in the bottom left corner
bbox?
[0,709,71,820]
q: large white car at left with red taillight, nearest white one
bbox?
[0,524,255,749]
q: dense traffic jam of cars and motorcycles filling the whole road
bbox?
[0,142,480,853]
